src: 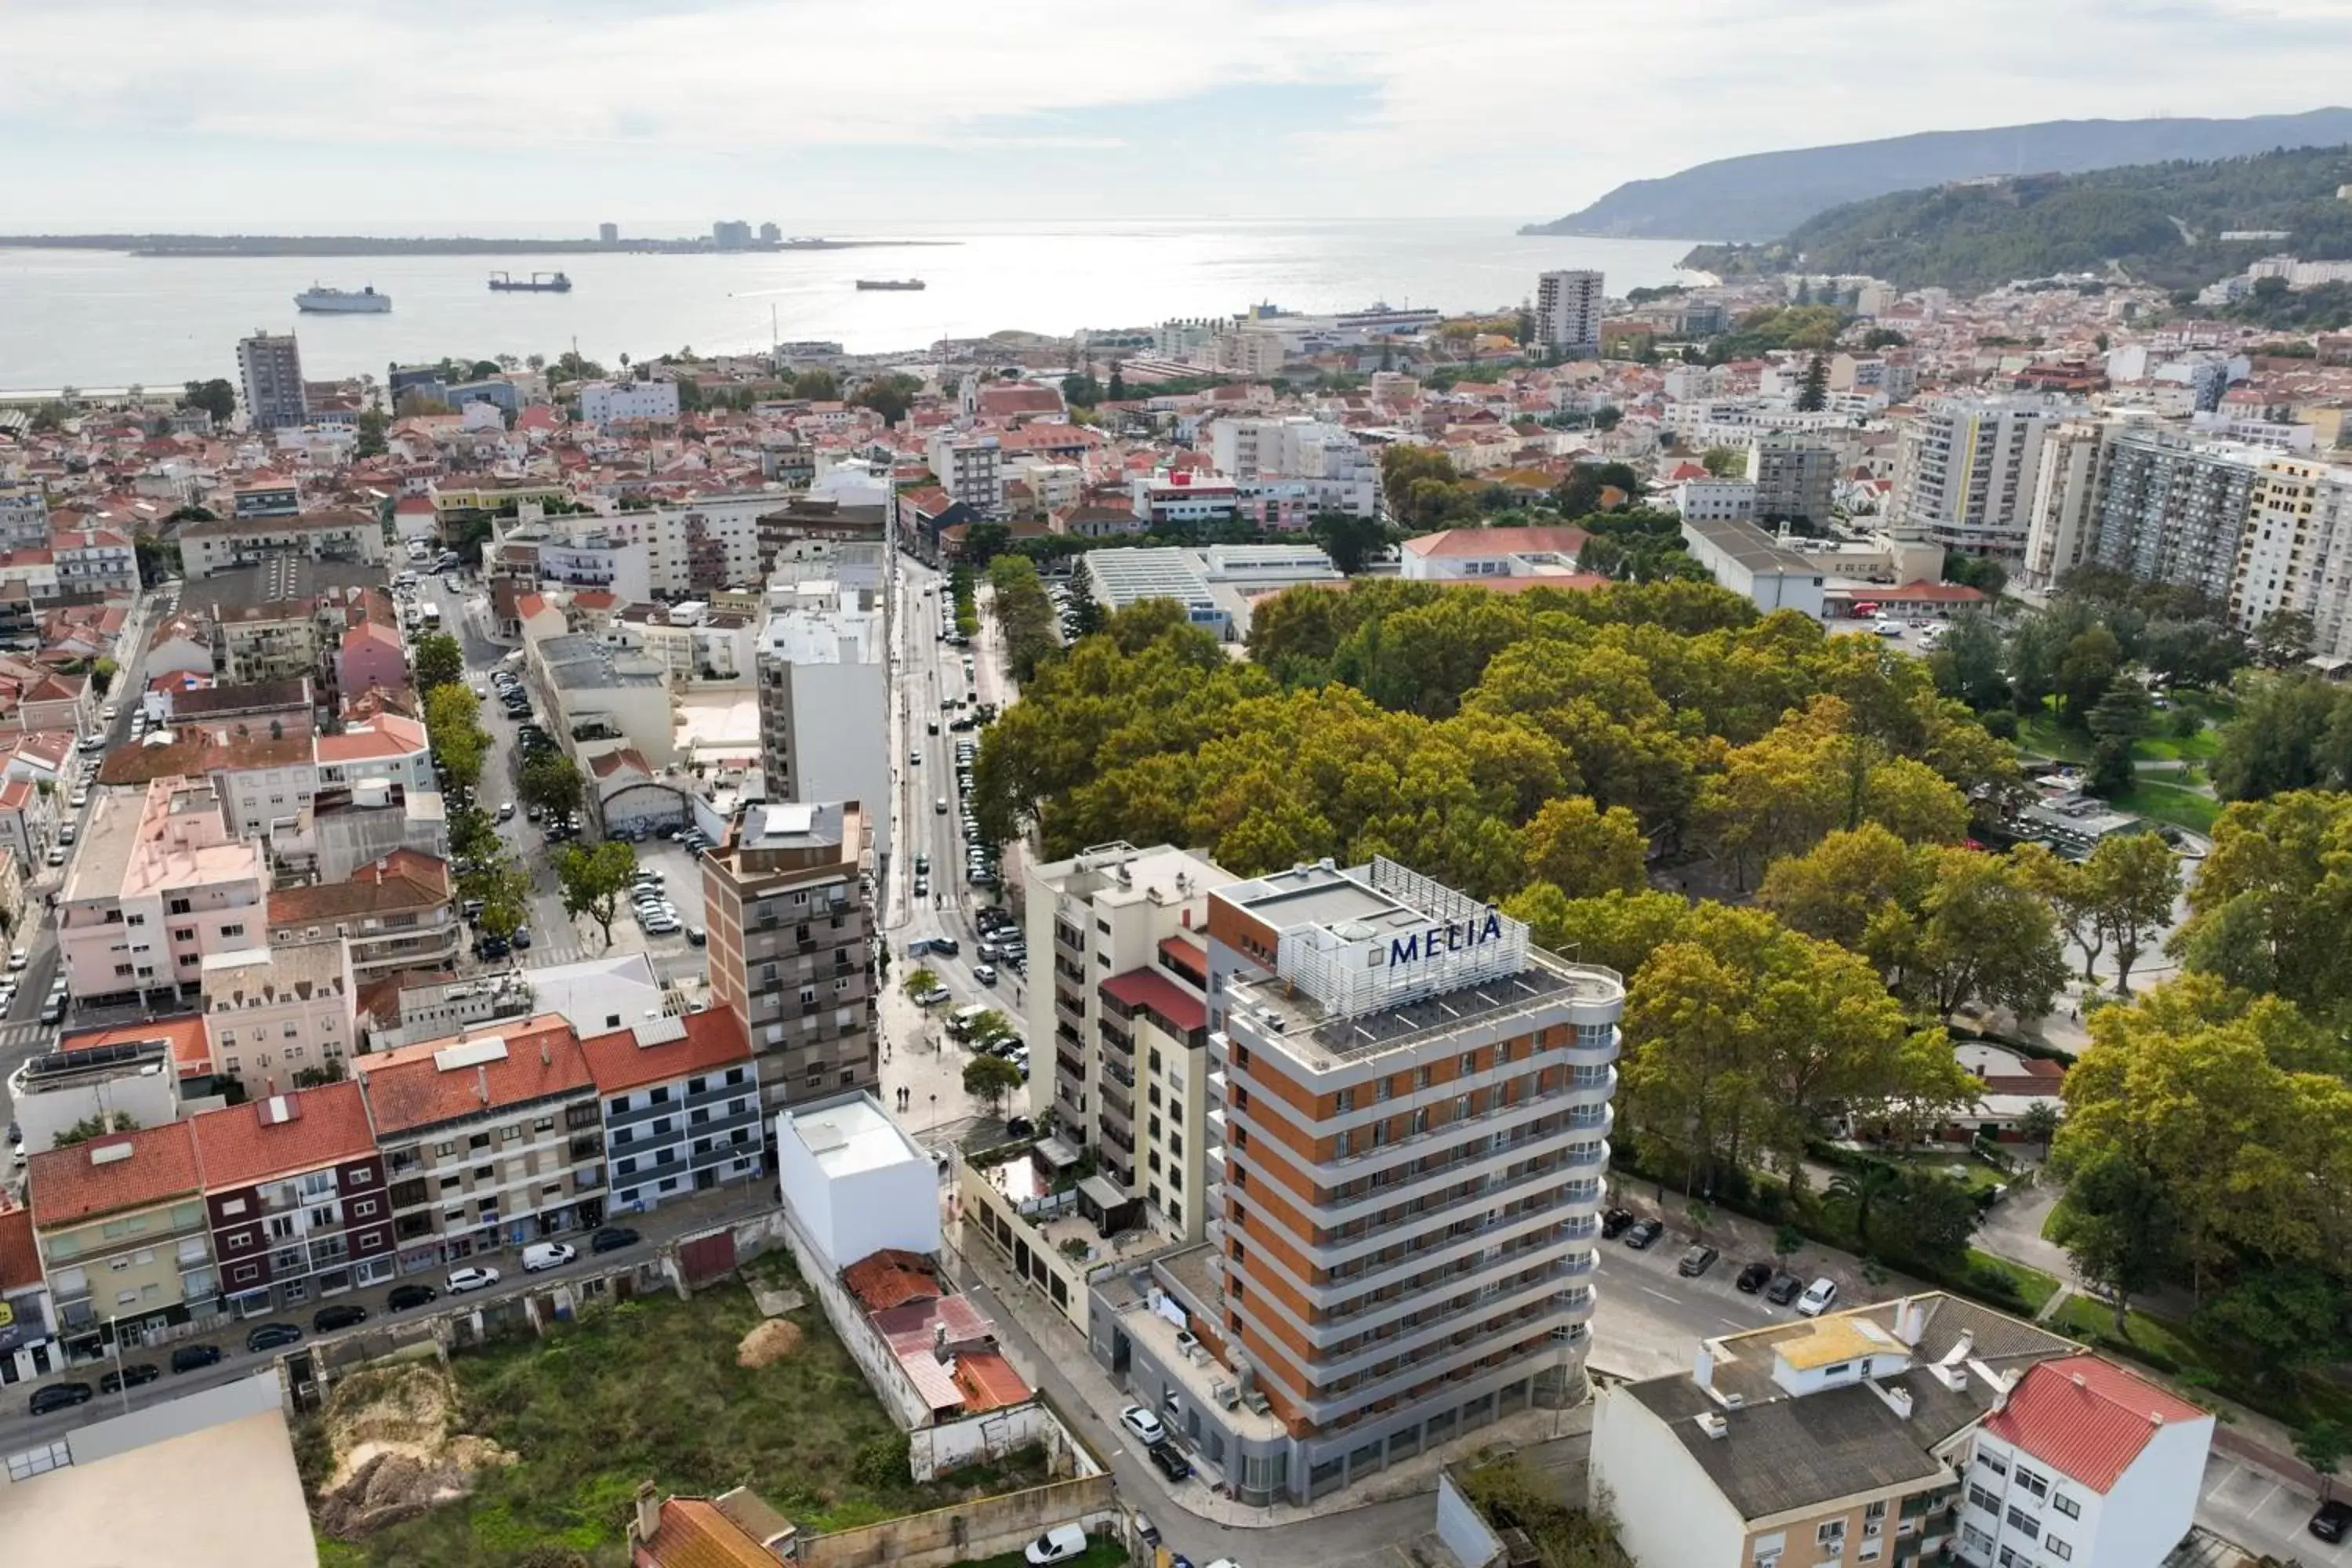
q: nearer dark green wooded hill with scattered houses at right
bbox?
[1684,148,2352,289]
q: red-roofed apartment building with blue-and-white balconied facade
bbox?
[581,1008,767,1215]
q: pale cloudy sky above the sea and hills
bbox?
[0,0,2352,235]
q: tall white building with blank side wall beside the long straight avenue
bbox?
[753,583,894,867]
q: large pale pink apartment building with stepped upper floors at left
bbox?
[56,779,268,1004]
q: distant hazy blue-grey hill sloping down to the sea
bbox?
[1519,108,2352,240]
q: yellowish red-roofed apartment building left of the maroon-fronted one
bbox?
[28,1121,219,1356]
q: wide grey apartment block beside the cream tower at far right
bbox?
[2093,426,2272,604]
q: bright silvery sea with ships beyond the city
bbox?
[0,216,1691,393]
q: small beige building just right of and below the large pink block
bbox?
[202,935,360,1095]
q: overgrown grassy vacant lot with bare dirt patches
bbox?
[315,1260,1040,1568]
